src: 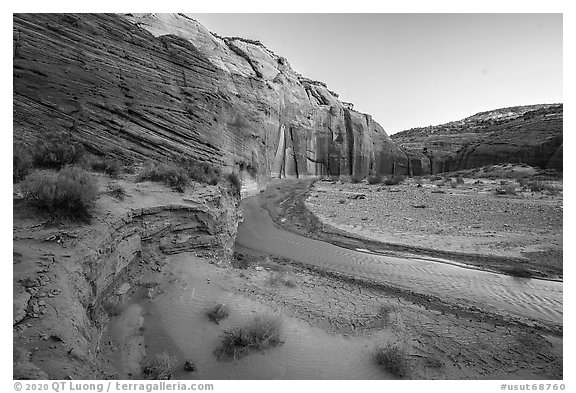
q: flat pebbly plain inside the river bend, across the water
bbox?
[306,167,563,279]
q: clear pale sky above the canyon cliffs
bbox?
[190,14,563,134]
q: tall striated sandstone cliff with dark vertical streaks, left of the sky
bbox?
[13,14,409,182]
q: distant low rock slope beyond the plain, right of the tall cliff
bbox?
[392,104,563,174]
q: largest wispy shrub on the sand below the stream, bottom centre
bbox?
[214,316,281,361]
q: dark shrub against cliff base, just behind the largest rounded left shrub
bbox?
[32,133,85,169]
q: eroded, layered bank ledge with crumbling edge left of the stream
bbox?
[13,186,239,380]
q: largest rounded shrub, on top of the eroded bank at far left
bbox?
[22,166,98,221]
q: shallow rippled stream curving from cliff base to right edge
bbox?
[236,188,562,324]
